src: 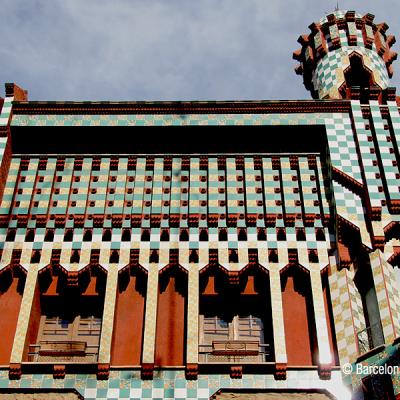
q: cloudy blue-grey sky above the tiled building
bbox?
[0,0,400,101]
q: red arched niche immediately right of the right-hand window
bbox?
[281,265,318,366]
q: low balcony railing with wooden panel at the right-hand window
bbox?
[199,340,272,363]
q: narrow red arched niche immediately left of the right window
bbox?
[155,266,188,366]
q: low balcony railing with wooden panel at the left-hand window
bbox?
[28,340,99,363]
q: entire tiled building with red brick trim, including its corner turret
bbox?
[0,11,400,400]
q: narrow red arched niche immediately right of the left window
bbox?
[111,266,147,366]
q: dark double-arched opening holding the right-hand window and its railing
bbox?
[199,266,274,364]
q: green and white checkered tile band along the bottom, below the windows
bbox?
[0,370,350,400]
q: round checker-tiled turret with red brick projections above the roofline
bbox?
[293,10,397,99]
